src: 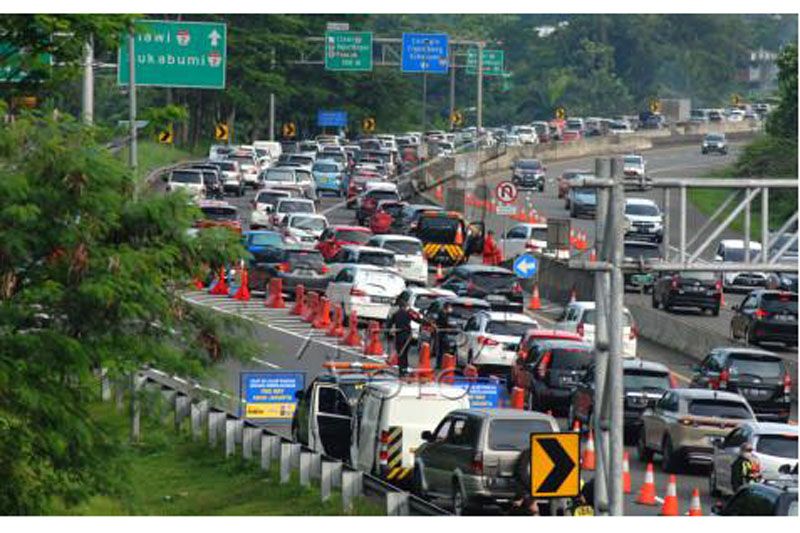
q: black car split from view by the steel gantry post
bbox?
[567,359,675,442]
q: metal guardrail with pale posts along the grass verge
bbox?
[109,368,451,516]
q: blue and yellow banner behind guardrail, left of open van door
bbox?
[240,372,306,423]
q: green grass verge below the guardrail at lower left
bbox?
[54,403,384,516]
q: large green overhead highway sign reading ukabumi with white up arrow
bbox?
[117,20,227,89]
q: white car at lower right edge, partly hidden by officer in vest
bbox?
[708,422,797,497]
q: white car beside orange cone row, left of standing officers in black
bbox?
[325,265,406,320]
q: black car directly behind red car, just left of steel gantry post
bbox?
[523,339,593,415]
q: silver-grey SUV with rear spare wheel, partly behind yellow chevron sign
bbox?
[413,409,559,514]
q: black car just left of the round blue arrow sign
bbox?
[440,264,522,311]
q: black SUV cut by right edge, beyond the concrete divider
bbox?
[731,290,797,348]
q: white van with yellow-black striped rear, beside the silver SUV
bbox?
[350,379,469,483]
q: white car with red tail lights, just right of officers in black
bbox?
[456,311,539,376]
